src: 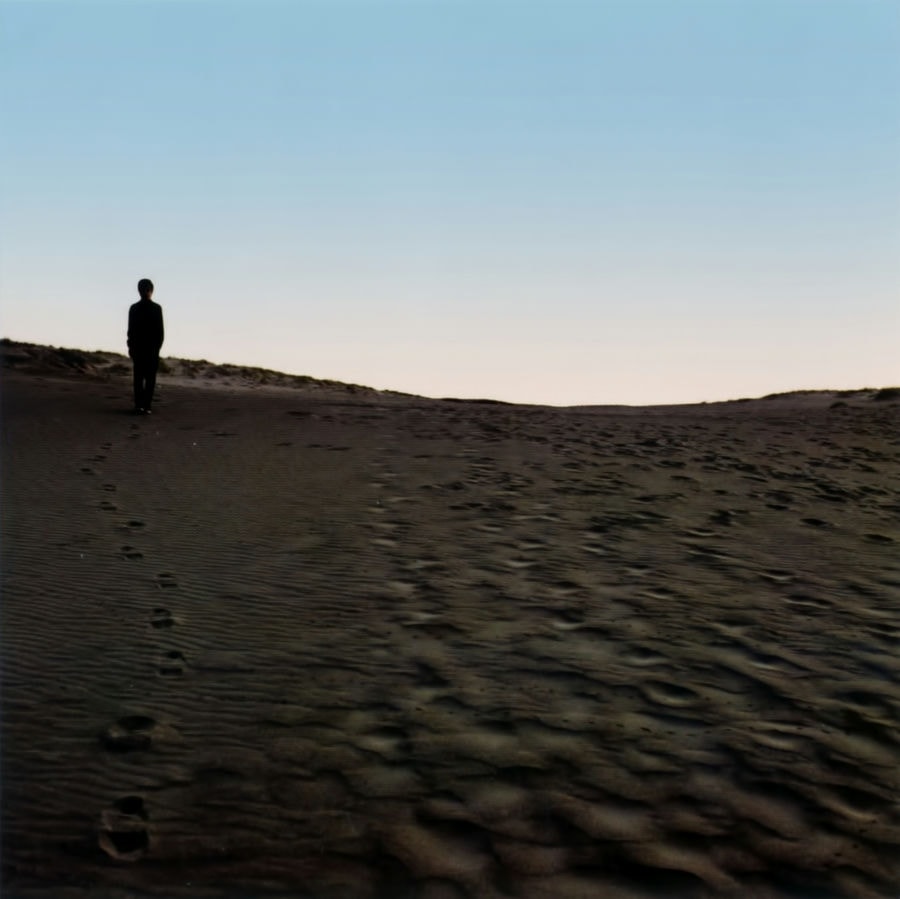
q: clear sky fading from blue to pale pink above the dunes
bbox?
[0,0,900,405]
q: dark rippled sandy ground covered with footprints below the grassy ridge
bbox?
[2,346,900,899]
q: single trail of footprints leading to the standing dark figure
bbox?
[81,436,187,862]
